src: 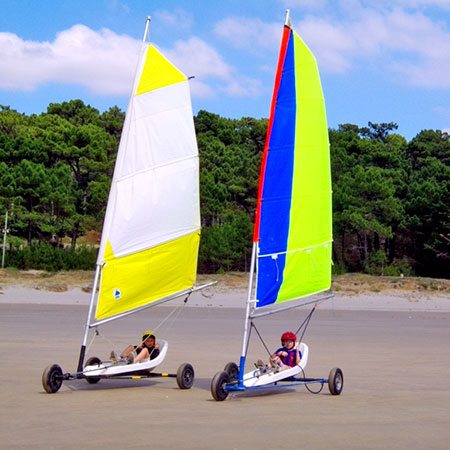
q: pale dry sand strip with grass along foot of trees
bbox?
[0,270,450,312]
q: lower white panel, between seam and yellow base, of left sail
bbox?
[103,159,200,258]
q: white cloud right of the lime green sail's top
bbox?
[298,9,450,88]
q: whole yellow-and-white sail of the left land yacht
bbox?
[96,39,200,319]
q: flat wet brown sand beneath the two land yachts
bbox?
[0,298,450,449]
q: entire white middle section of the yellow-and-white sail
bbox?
[98,57,200,264]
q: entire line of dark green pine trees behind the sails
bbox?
[0,100,450,278]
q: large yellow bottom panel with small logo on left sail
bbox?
[96,232,200,320]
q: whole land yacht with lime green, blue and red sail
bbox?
[211,11,343,401]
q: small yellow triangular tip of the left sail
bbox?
[136,45,187,95]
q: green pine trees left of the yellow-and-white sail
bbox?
[0,100,119,251]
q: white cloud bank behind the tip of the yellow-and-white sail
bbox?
[0,25,259,97]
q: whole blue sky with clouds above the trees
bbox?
[0,0,450,140]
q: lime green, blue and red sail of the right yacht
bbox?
[253,22,332,307]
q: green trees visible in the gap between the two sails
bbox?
[195,111,267,272]
